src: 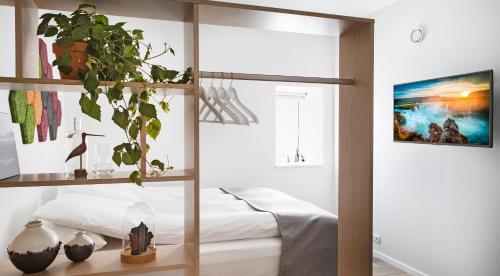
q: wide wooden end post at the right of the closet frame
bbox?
[339,23,373,276]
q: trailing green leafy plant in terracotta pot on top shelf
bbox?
[38,4,192,185]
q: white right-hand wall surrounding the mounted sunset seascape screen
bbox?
[374,0,500,276]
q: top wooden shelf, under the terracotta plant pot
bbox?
[0,77,194,95]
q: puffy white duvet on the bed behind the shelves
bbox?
[35,184,279,244]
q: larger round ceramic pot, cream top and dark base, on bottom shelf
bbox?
[7,220,61,273]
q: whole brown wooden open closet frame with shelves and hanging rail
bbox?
[0,0,374,276]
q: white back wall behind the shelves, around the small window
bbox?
[0,6,338,257]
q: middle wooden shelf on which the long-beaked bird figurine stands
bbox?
[0,170,194,189]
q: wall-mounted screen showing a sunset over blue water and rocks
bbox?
[394,71,493,146]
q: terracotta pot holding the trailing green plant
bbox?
[52,42,88,80]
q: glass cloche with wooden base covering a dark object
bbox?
[121,202,156,264]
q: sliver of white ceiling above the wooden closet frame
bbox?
[224,0,397,17]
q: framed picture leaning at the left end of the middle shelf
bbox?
[0,112,19,180]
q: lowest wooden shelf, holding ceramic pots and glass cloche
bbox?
[0,245,193,276]
